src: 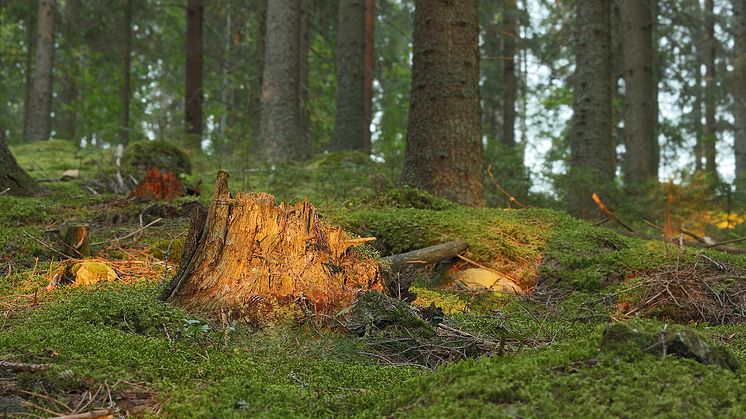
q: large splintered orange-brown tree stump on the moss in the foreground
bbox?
[166,171,382,319]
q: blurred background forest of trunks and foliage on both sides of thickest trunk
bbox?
[0,0,746,225]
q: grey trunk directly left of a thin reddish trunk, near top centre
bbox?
[331,0,368,151]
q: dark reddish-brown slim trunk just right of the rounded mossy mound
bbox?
[184,0,204,141]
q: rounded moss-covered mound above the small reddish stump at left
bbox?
[122,141,192,179]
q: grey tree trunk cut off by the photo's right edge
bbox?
[733,0,746,197]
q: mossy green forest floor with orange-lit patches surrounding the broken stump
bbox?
[0,143,746,417]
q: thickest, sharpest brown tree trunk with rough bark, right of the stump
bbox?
[402,0,485,206]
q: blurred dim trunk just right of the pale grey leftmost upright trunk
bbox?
[57,0,82,142]
